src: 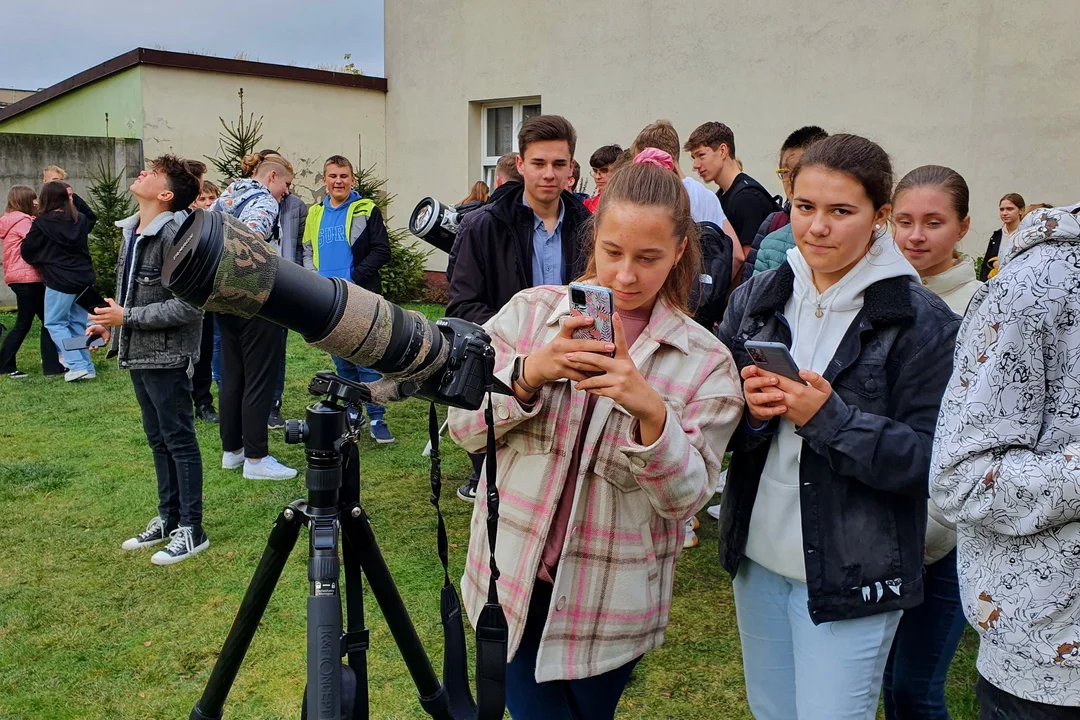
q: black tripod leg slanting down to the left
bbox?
[189,506,303,720]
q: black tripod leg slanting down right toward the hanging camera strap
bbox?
[341,508,454,720]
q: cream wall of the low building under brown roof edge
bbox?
[143,66,386,205]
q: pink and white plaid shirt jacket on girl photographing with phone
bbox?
[449,286,743,682]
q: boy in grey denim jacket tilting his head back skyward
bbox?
[86,155,210,565]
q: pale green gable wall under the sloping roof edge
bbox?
[0,67,144,138]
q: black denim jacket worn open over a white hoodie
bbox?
[717,262,960,624]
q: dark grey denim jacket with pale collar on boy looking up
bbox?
[108,213,202,375]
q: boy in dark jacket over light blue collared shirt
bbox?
[446,116,591,502]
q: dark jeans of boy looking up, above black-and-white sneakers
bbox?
[132,368,202,528]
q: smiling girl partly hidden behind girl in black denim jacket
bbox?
[883,165,982,720]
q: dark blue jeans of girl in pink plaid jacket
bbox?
[507,580,642,720]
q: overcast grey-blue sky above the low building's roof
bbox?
[0,0,382,90]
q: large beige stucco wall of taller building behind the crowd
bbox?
[386,0,1080,267]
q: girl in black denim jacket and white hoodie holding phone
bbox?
[719,135,959,720]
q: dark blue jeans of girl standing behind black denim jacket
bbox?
[882,549,968,720]
